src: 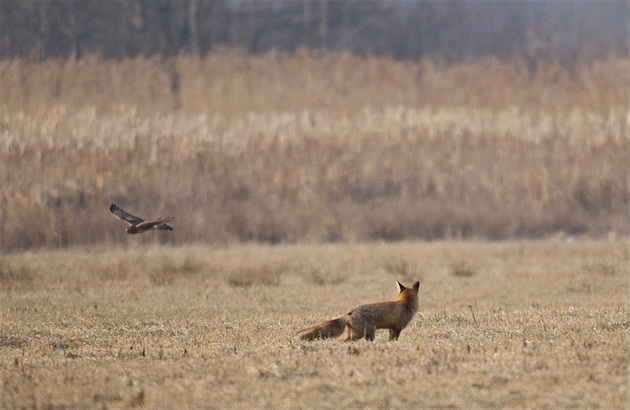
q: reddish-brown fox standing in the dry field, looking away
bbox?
[297,281,420,342]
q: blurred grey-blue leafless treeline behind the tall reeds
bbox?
[0,0,630,65]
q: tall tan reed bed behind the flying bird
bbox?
[0,53,630,249]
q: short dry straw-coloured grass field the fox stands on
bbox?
[0,240,630,409]
